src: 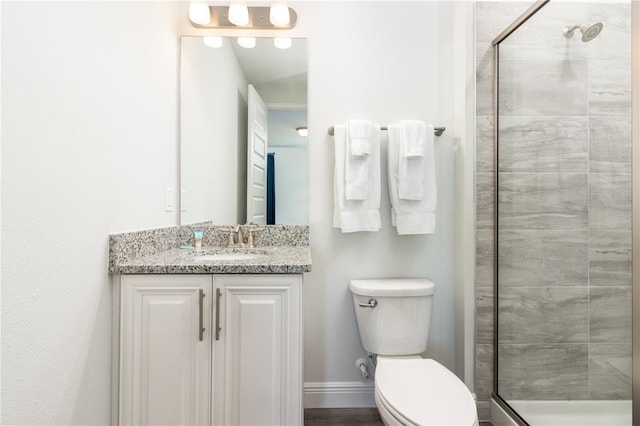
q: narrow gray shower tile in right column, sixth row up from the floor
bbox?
[589,58,631,115]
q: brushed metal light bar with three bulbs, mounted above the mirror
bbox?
[189,4,298,30]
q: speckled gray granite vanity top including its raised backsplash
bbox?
[109,225,311,274]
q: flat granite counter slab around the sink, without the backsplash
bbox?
[113,246,311,274]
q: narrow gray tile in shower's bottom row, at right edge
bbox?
[589,343,632,400]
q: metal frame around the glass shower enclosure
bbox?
[492,0,640,426]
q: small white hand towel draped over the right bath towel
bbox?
[398,120,433,200]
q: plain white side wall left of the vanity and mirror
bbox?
[0,2,184,425]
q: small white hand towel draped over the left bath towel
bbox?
[345,120,372,200]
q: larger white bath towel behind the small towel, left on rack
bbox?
[333,124,382,233]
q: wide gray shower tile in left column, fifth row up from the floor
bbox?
[498,116,589,173]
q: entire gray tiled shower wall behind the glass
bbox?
[476,1,631,419]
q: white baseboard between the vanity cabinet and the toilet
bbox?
[304,382,376,408]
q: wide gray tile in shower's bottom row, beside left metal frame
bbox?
[498,344,589,400]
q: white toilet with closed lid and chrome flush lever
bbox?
[349,279,479,426]
